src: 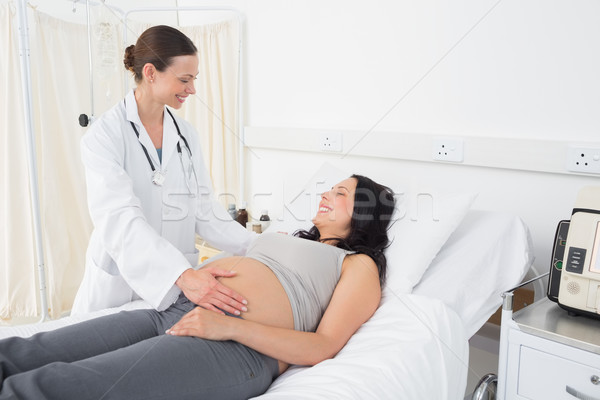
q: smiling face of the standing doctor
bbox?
[152,55,198,109]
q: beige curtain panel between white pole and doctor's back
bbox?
[31,12,104,318]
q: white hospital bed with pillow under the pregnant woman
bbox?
[0,176,533,400]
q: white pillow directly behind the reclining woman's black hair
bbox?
[384,191,477,294]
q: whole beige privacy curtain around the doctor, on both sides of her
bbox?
[0,3,239,320]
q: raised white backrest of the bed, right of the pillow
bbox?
[413,210,534,337]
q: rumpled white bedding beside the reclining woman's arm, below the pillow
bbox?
[257,294,469,400]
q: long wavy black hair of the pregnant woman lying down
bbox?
[294,174,395,286]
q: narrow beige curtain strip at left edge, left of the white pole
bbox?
[0,3,37,319]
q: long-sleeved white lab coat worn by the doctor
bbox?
[72,90,256,314]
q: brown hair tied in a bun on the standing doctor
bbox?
[123,25,198,83]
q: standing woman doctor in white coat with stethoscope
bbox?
[72,26,256,315]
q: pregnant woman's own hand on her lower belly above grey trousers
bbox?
[166,307,237,340]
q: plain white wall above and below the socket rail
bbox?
[240,0,600,280]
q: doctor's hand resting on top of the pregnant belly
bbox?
[175,267,248,315]
